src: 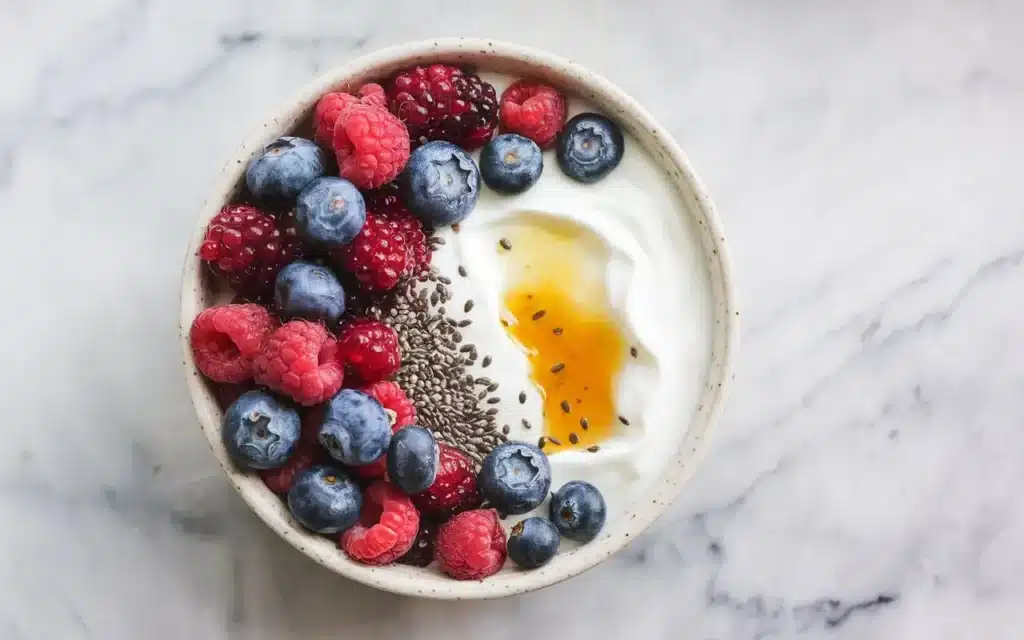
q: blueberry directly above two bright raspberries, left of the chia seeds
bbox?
[273,260,345,329]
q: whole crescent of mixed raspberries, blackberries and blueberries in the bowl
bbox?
[190,65,623,580]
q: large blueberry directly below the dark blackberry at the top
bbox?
[399,140,480,226]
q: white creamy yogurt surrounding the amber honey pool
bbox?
[423,74,713,524]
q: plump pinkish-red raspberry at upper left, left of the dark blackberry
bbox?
[332,100,410,188]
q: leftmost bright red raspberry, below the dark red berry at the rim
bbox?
[188,304,278,382]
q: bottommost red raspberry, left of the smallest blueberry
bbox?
[434,509,505,580]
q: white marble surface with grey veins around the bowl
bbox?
[0,0,1024,640]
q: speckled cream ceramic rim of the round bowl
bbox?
[180,38,738,599]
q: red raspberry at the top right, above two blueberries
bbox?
[500,80,565,148]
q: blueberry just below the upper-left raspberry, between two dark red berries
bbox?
[295,178,367,249]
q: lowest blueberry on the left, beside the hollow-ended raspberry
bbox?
[288,465,362,534]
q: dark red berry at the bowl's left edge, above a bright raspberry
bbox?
[199,205,305,299]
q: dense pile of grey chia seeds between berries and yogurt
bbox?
[367,261,508,464]
